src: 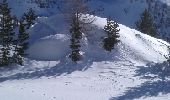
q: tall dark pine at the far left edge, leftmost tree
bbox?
[0,0,14,66]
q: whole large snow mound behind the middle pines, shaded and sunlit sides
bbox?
[26,15,169,64]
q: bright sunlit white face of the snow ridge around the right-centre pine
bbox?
[89,17,169,65]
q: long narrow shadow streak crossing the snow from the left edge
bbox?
[0,53,118,82]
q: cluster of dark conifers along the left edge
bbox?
[0,0,37,66]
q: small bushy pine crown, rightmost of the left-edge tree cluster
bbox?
[22,8,37,29]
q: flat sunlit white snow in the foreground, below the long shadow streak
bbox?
[0,62,145,100]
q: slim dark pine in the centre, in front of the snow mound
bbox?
[69,15,82,62]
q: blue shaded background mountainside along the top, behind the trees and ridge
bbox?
[8,0,170,40]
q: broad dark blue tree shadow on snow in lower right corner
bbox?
[110,62,170,100]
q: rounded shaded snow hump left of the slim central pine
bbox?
[28,34,69,60]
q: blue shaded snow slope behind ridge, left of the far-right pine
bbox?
[92,0,147,28]
